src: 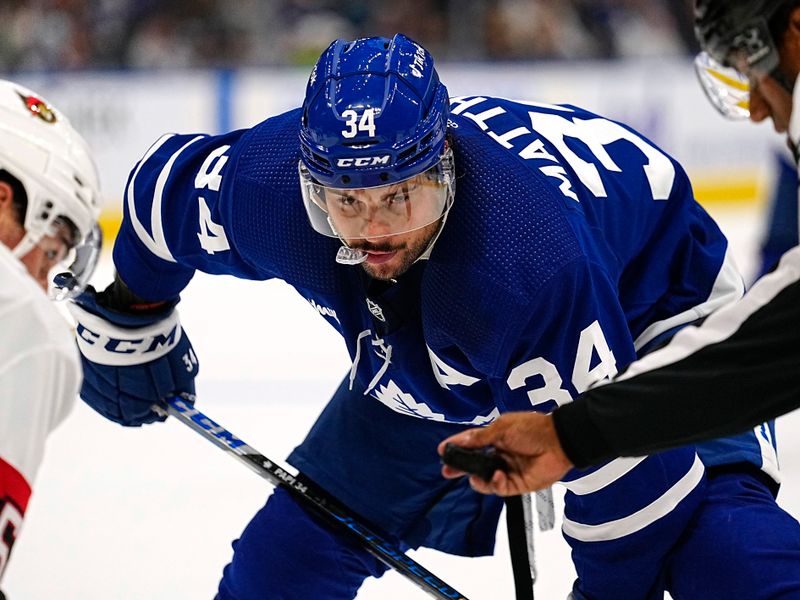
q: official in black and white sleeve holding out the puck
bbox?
[440,0,800,494]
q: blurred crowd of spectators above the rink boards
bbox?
[0,0,695,73]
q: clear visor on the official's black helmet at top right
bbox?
[694,52,750,121]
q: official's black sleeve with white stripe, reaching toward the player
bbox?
[553,247,800,467]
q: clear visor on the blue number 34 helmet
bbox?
[299,150,454,241]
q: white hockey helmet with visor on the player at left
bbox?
[0,79,101,299]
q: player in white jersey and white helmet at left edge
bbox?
[0,80,100,596]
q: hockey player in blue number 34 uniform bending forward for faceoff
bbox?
[65,35,796,600]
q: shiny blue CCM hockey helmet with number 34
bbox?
[300,34,449,188]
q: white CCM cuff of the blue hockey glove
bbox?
[68,303,183,367]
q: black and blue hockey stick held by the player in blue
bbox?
[158,396,467,600]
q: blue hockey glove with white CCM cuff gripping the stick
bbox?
[68,280,199,426]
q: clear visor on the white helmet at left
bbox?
[50,223,103,300]
